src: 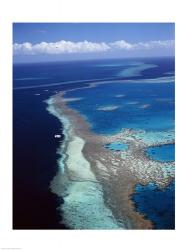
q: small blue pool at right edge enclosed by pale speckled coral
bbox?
[147,144,175,162]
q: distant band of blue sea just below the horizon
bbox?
[13,57,174,87]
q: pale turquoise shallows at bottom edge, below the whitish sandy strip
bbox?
[62,182,123,229]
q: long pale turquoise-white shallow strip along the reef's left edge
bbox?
[47,98,124,229]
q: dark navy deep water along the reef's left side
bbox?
[13,90,64,229]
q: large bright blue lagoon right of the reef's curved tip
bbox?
[65,81,174,134]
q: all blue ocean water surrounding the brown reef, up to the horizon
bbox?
[13,58,175,229]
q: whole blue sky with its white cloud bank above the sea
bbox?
[13,23,175,63]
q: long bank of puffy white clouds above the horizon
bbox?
[13,40,174,55]
